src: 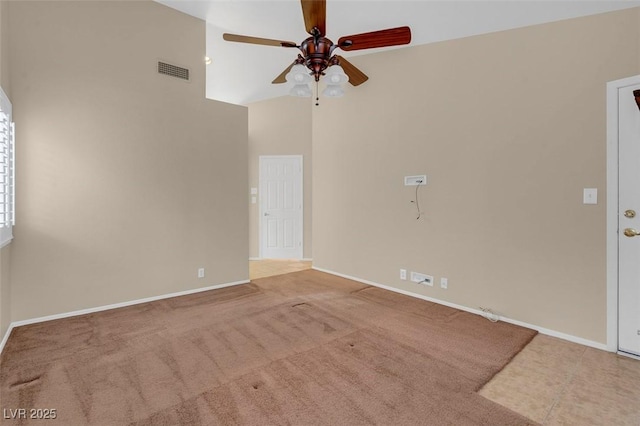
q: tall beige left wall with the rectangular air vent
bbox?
[9,1,249,321]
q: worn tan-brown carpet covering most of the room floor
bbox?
[0,271,536,426]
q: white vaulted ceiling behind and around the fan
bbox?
[156,0,640,105]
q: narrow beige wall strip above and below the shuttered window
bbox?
[0,1,11,341]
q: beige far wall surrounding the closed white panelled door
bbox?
[247,96,312,258]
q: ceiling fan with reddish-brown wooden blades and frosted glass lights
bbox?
[222,0,411,99]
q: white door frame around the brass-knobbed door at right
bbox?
[607,75,640,355]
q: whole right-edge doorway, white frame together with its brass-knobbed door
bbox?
[607,76,640,356]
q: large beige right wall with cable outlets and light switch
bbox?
[313,8,640,343]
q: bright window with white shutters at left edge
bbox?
[0,88,15,247]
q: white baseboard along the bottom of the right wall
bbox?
[311,266,607,351]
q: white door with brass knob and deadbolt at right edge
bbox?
[618,84,640,355]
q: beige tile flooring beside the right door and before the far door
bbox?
[250,260,640,426]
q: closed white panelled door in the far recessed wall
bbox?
[259,155,303,259]
